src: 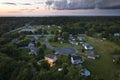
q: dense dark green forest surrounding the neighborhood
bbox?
[0,17,120,80]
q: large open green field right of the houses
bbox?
[85,37,120,80]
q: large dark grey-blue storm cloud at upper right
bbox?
[46,0,120,10]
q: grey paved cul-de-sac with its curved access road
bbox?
[45,35,76,55]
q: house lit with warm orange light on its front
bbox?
[45,54,57,67]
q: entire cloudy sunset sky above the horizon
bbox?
[0,0,120,16]
